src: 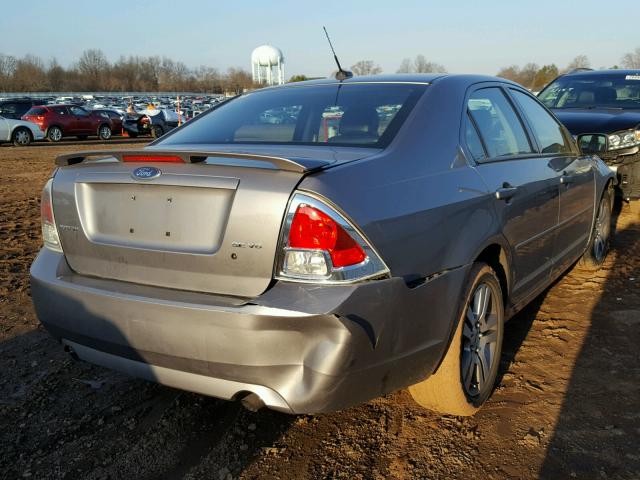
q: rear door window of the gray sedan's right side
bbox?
[467,87,534,158]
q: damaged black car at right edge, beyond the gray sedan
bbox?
[539,70,640,200]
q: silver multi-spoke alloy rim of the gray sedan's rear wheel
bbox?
[460,282,499,397]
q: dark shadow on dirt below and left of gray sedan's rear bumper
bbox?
[0,327,295,479]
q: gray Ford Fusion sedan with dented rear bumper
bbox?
[31,74,615,415]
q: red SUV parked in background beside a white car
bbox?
[22,105,113,142]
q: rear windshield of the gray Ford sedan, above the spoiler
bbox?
[159,83,426,148]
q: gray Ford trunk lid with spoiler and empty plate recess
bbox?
[52,149,331,297]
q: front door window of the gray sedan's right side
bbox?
[511,89,571,153]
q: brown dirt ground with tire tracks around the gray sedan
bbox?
[0,141,640,479]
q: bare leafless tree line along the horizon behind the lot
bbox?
[0,47,640,93]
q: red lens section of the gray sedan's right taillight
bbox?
[289,204,367,268]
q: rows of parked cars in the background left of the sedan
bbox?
[0,97,222,146]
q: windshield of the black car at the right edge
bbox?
[538,73,640,109]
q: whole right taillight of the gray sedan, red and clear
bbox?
[278,193,389,283]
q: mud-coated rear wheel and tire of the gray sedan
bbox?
[409,263,504,416]
